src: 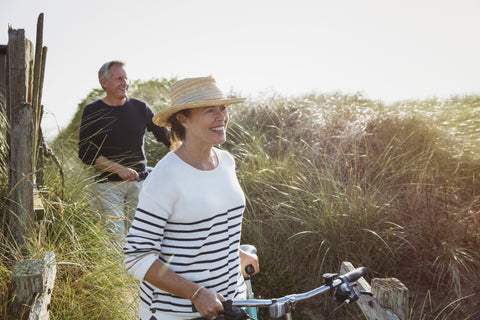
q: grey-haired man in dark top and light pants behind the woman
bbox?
[78,61,170,237]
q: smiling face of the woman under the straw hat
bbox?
[181,105,228,146]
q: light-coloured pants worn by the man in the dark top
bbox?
[93,181,143,237]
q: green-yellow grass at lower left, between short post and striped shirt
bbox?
[0,141,138,320]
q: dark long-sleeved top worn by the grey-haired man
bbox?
[78,97,170,181]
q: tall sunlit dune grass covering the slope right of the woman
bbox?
[227,95,480,319]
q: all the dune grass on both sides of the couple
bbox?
[0,79,480,319]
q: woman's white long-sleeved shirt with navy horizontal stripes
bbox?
[124,148,245,319]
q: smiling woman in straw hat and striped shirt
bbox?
[124,77,259,320]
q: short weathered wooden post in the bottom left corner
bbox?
[11,251,57,320]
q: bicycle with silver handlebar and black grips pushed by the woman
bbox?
[193,245,372,320]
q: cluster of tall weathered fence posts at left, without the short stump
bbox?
[5,14,47,247]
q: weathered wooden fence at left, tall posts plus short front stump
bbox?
[0,14,58,320]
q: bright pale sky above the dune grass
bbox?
[0,0,480,137]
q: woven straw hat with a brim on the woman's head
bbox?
[153,76,245,126]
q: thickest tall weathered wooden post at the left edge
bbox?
[7,29,34,246]
